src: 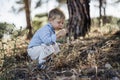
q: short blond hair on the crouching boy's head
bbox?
[48,8,65,20]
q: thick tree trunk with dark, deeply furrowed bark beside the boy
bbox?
[67,0,91,40]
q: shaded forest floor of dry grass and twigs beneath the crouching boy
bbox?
[0,28,120,80]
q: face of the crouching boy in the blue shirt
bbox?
[50,18,64,30]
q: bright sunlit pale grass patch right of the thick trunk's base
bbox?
[86,23,120,38]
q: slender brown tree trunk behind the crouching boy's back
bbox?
[24,0,32,39]
